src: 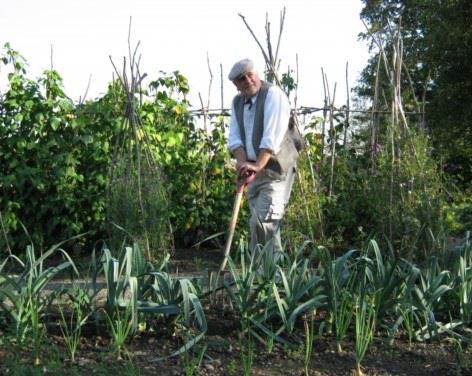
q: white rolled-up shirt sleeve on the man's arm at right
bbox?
[260,86,290,154]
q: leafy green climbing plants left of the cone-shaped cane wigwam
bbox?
[0,44,115,251]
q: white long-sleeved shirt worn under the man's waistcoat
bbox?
[228,85,290,161]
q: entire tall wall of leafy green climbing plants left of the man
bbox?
[0,44,238,260]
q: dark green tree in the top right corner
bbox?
[357,0,472,186]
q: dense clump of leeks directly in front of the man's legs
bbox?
[226,243,325,351]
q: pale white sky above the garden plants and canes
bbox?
[0,0,368,108]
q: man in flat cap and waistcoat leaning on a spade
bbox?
[228,59,298,261]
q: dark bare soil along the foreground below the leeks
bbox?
[0,310,472,376]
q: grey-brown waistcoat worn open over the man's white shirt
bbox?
[233,82,298,179]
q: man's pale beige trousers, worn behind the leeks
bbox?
[247,166,296,262]
